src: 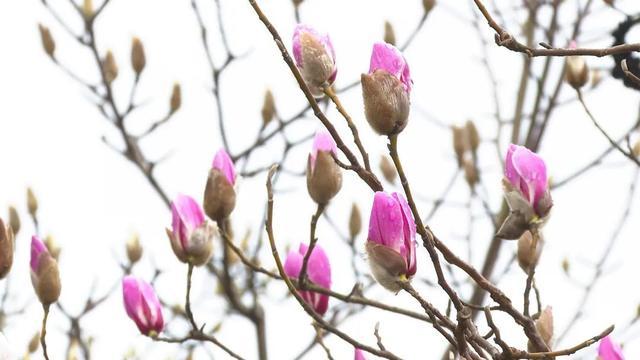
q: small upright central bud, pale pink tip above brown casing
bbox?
[307,131,342,204]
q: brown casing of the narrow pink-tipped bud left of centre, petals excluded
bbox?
[203,168,236,221]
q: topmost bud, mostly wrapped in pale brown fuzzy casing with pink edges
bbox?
[293,24,338,97]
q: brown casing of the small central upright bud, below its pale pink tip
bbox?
[307,151,342,204]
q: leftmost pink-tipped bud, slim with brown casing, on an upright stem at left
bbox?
[30,235,61,306]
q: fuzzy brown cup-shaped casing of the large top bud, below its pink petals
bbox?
[360,70,410,136]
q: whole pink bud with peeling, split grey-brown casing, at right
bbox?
[497,144,553,239]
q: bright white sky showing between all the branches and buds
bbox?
[0,0,640,359]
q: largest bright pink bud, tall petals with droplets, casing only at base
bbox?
[366,191,416,292]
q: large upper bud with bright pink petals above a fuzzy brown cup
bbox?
[360,43,411,136]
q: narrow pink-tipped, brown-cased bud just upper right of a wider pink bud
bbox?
[204,149,236,221]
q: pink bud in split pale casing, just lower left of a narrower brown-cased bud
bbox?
[167,195,215,266]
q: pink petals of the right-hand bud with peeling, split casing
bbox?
[504,144,553,218]
